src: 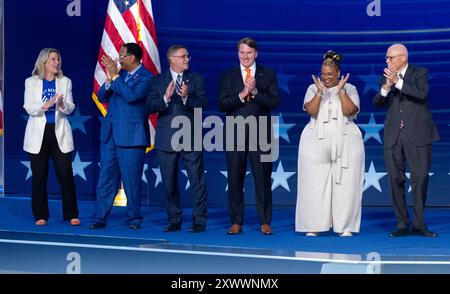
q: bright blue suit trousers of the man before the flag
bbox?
[95,135,145,224]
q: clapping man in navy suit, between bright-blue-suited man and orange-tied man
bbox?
[147,45,208,233]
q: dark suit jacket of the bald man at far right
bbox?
[373,64,439,148]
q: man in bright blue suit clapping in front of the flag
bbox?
[90,43,152,229]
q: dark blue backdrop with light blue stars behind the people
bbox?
[4,0,450,206]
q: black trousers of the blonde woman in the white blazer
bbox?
[28,124,78,220]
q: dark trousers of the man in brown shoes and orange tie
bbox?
[226,151,272,225]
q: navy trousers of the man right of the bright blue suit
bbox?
[157,150,208,225]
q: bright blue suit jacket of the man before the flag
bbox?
[98,65,152,146]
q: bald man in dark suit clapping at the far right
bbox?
[373,44,439,237]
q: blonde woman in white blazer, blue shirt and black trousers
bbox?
[23,48,80,225]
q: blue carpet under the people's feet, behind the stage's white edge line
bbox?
[0,196,450,256]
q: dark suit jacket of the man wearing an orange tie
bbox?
[219,65,280,145]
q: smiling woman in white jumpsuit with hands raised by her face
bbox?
[295,51,365,237]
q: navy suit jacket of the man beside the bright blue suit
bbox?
[147,70,208,152]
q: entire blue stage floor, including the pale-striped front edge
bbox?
[0,197,450,274]
